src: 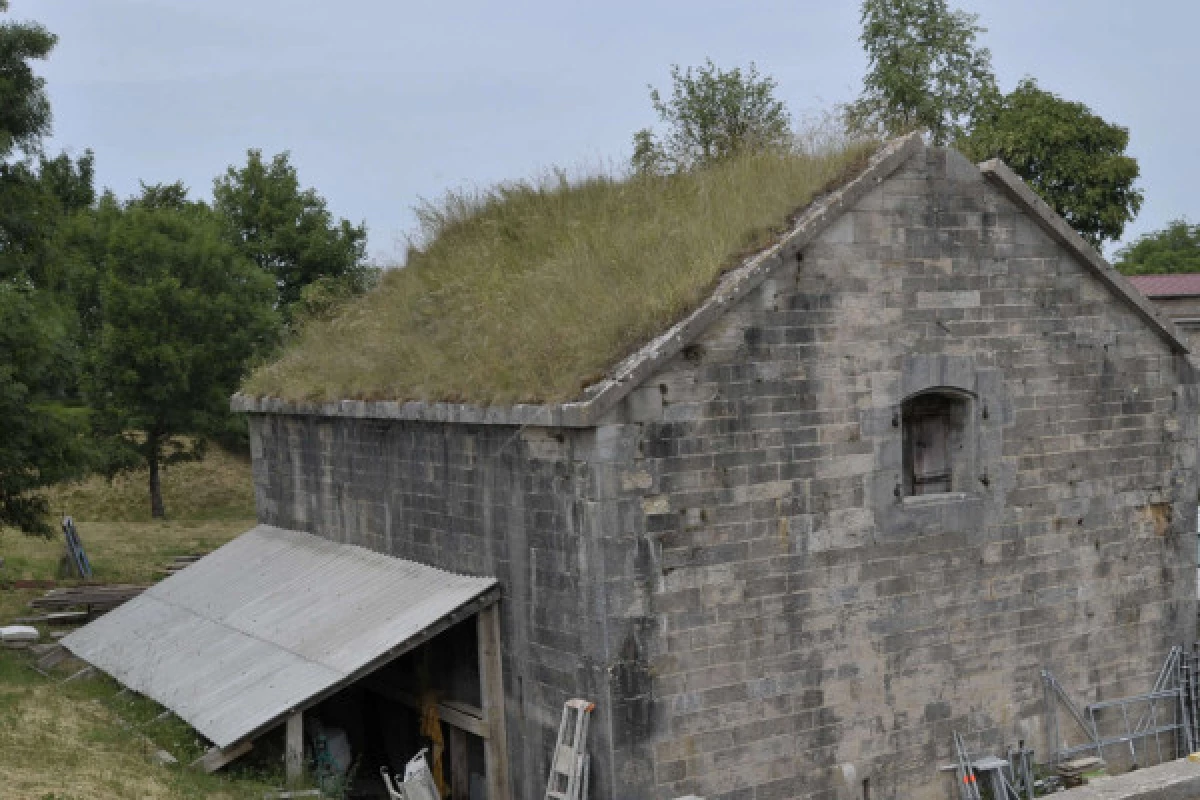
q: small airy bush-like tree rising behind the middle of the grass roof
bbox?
[632,60,792,173]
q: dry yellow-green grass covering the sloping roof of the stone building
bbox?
[242,143,876,404]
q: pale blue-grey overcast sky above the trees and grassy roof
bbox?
[18,0,1200,261]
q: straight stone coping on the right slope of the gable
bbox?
[979,158,1192,354]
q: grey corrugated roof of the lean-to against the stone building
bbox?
[62,525,496,747]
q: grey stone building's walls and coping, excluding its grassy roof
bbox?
[234,137,1198,800]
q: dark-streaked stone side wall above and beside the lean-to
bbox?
[250,415,633,798]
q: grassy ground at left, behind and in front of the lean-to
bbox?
[0,450,280,800]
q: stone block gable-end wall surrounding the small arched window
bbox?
[600,149,1198,800]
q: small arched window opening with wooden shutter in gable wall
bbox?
[901,390,972,497]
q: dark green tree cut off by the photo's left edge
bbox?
[0,6,91,534]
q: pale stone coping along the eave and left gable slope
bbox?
[229,132,924,428]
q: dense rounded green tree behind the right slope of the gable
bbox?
[955,78,1142,248]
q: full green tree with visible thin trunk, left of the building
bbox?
[90,185,278,518]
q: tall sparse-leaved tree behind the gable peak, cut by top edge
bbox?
[846,0,998,145]
